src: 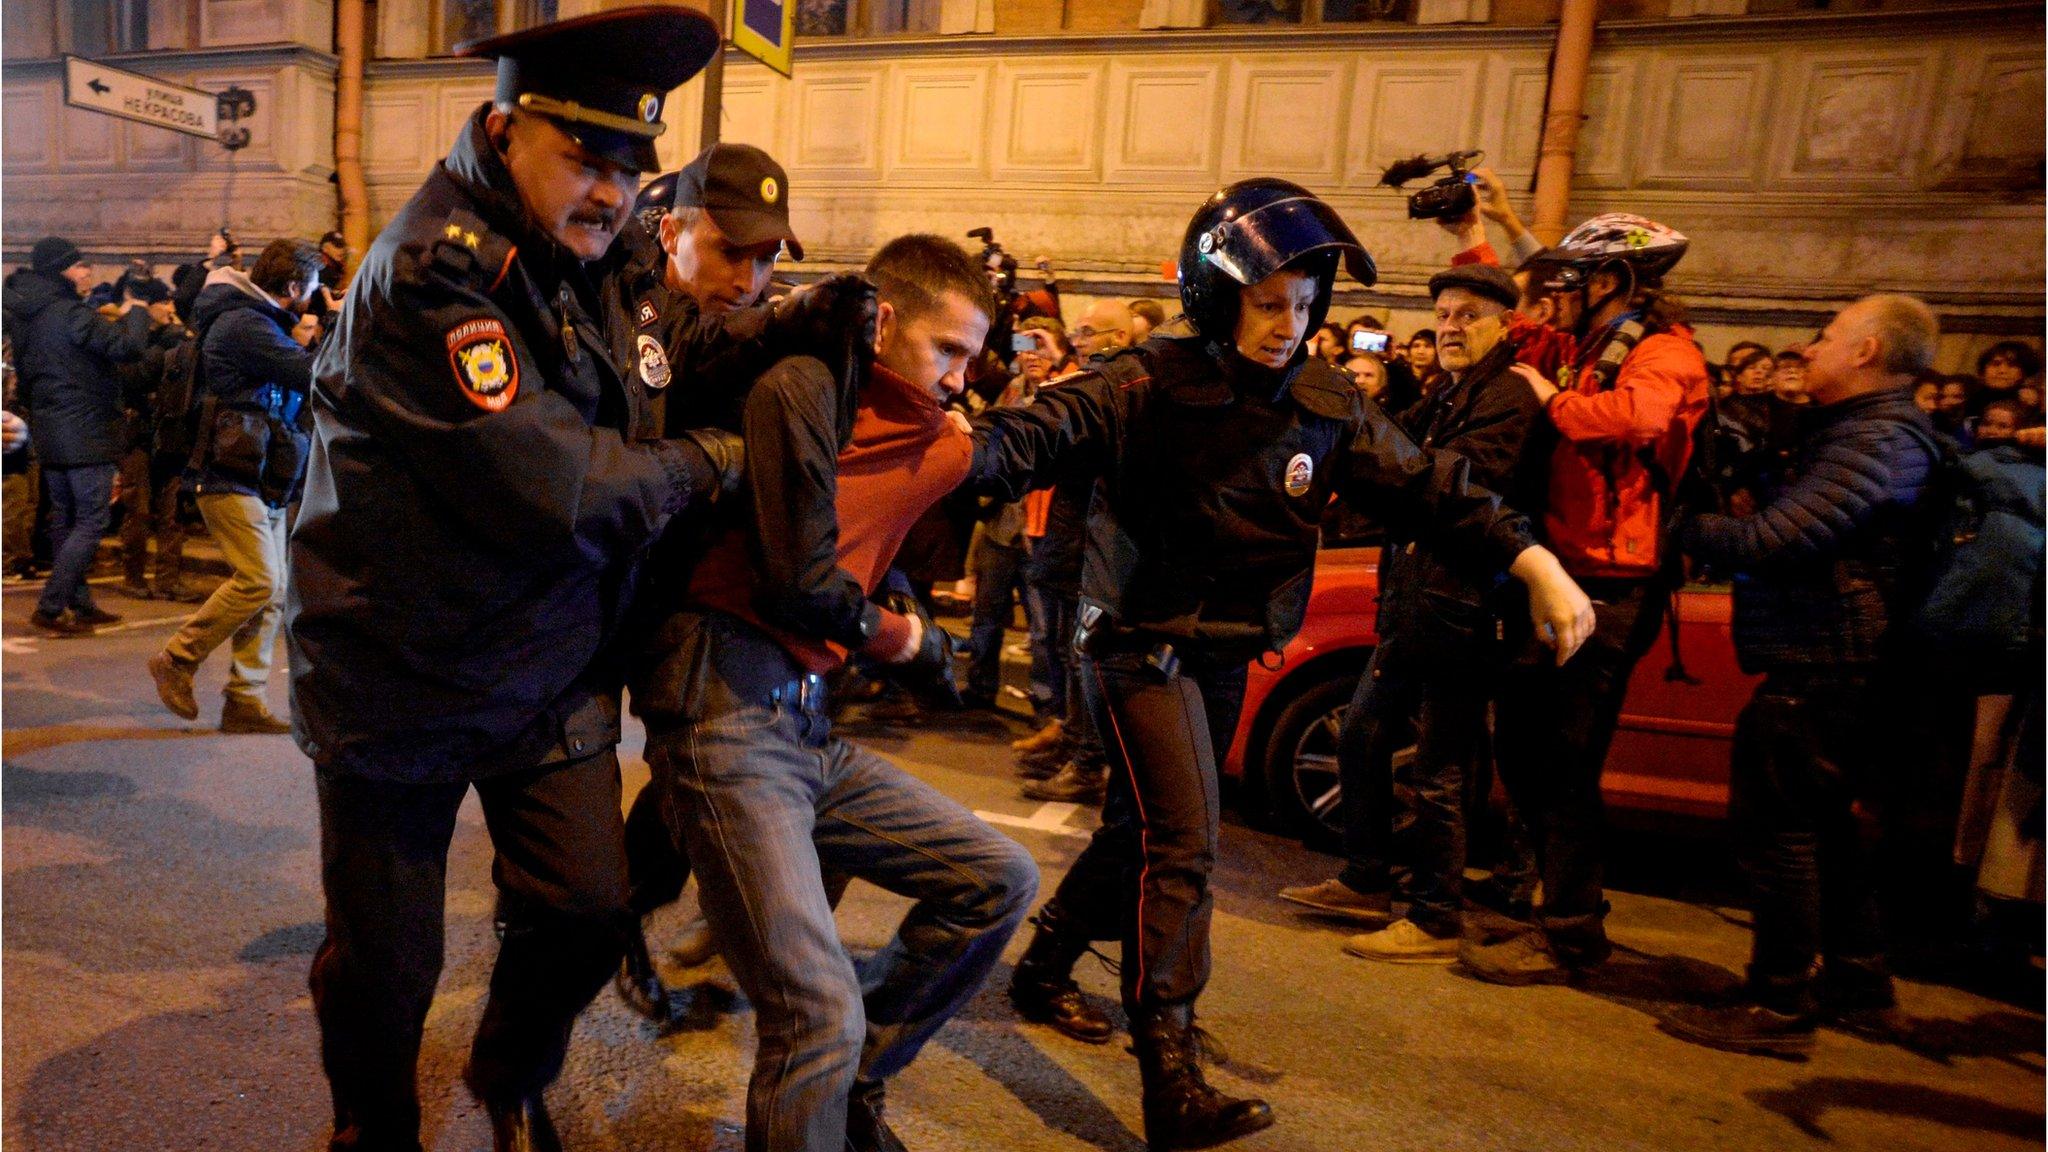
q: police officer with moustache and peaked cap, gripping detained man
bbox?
[287,6,864,1150]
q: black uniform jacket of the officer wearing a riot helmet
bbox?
[969,336,1534,662]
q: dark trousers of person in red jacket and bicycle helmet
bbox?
[1495,580,1669,963]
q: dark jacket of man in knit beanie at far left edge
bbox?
[0,269,150,467]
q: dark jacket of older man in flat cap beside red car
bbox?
[1378,340,1556,646]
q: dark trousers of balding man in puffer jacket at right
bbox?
[1729,670,1907,1013]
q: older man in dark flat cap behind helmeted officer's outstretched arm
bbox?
[1280,264,1550,963]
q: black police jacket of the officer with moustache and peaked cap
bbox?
[285,109,758,781]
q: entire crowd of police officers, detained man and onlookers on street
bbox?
[4,8,2042,1152]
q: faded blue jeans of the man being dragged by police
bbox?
[647,631,1038,1152]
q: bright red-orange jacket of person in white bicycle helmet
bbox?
[1544,328,1708,576]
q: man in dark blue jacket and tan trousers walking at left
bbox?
[150,240,322,734]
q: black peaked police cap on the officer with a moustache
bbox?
[455,4,719,172]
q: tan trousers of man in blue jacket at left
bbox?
[164,492,287,703]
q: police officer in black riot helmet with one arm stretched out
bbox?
[969,178,1591,1150]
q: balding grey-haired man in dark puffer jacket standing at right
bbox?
[1667,295,1942,1054]
